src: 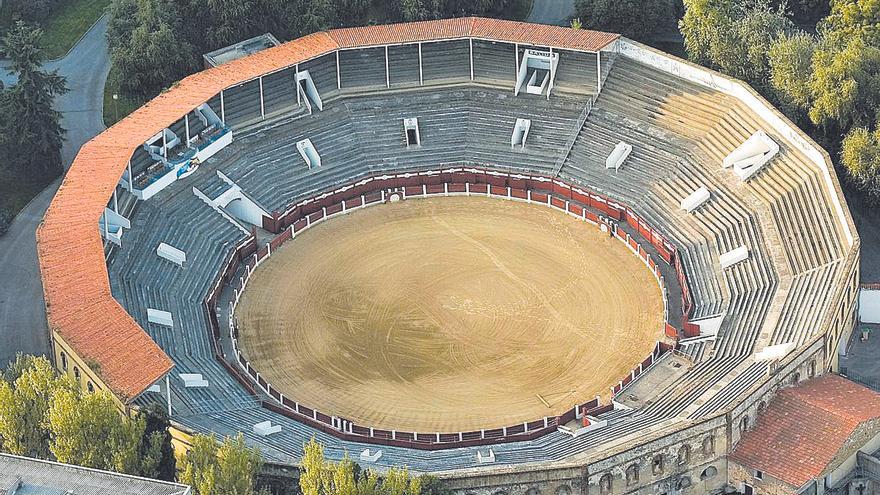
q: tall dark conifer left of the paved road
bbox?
[0,22,67,175]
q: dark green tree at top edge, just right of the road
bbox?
[575,0,673,41]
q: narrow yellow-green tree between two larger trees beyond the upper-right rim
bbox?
[767,32,816,115]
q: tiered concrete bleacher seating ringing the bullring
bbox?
[108,44,844,470]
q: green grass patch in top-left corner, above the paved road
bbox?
[42,0,110,59]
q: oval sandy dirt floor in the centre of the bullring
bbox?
[236,197,663,432]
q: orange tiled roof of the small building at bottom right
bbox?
[730,374,880,488]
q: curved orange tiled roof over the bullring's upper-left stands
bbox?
[37,17,618,401]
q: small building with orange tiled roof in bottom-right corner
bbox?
[728,374,880,493]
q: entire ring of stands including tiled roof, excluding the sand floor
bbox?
[38,18,859,493]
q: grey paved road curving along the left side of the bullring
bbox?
[0,16,110,366]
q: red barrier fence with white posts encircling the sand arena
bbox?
[205,168,686,450]
